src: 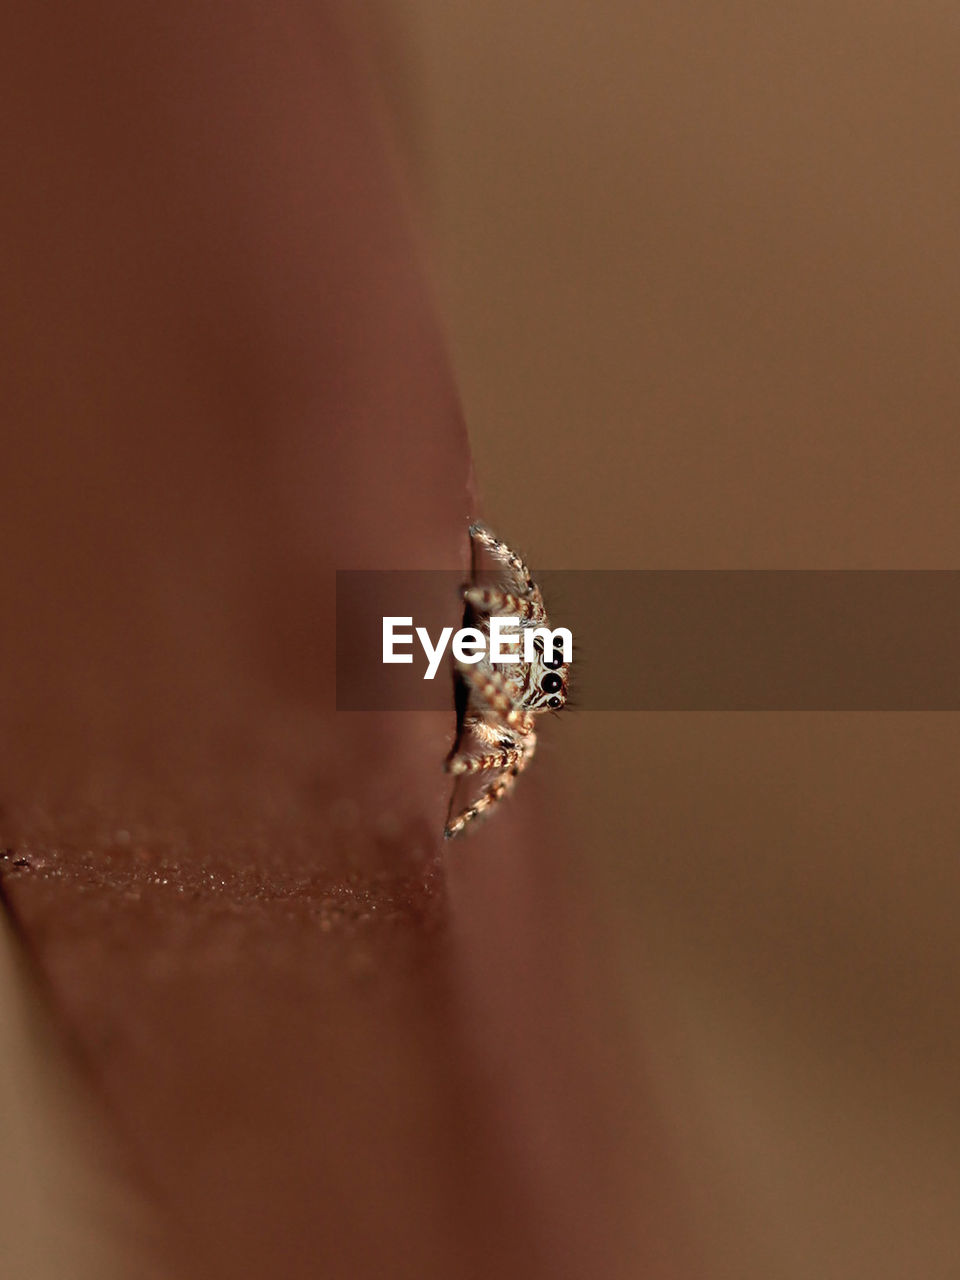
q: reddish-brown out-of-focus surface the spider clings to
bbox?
[0,4,675,1280]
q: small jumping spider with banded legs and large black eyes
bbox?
[443,525,570,838]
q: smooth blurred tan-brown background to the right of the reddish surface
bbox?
[5,0,960,1280]
